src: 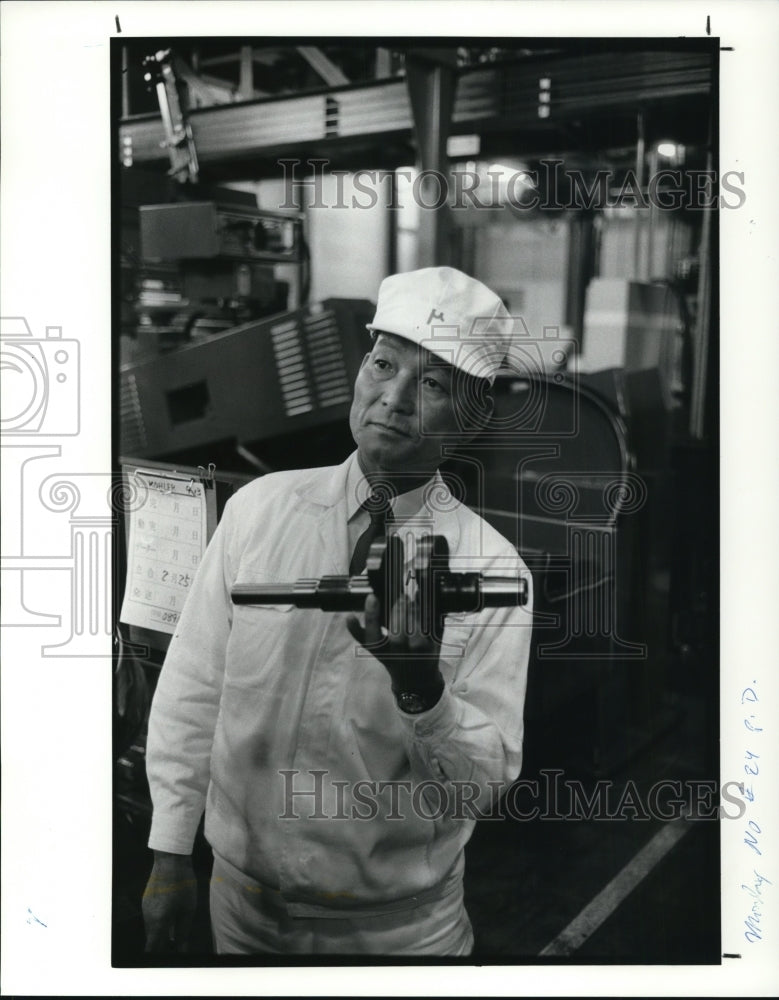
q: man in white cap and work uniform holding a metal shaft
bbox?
[144,268,532,956]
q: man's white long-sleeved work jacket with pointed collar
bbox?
[147,455,532,915]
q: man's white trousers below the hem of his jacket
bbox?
[211,855,473,956]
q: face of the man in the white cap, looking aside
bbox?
[349,333,478,474]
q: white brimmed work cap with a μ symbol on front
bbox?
[368,267,514,384]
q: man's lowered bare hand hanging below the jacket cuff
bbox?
[143,851,197,952]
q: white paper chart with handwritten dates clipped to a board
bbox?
[120,469,209,635]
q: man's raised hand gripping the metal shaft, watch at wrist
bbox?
[346,595,444,708]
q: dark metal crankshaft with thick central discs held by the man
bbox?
[231,535,528,636]
